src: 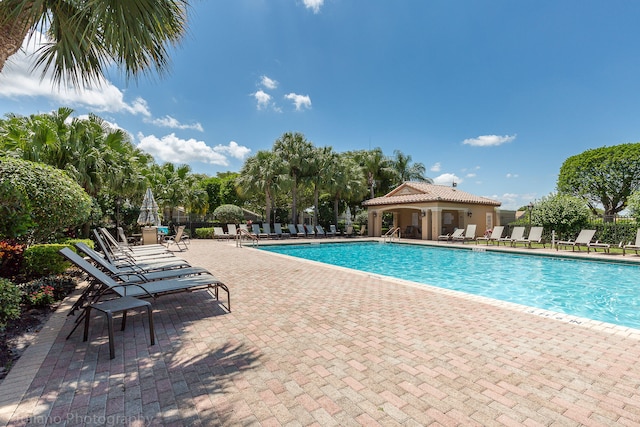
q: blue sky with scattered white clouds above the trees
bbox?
[0,0,640,209]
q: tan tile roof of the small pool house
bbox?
[362,182,502,206]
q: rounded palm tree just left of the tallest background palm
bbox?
[236,150,284,224]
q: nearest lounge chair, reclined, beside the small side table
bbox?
[60,248,231,312]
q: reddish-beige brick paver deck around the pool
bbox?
[0,239,640,427]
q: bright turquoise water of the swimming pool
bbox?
[260,242,640,329]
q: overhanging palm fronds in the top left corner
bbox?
[0,0,189,87]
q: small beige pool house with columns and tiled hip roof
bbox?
[362,181,501,240]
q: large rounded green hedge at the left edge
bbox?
[0,157,91,243]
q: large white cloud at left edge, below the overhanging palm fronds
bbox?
[0,36,151,117]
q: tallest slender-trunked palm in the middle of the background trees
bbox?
[273,132,313,223]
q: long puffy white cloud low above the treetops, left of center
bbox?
[138,133,251,166]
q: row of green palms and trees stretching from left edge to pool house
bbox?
[0,107,429,242]
